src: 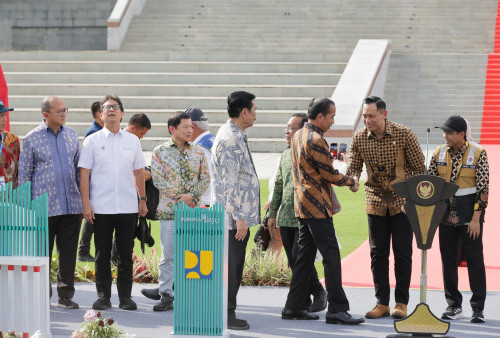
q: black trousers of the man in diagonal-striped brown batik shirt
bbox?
[285,217,349,313]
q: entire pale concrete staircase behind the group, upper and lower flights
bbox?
[0,0,498,151]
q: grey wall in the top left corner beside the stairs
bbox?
[0,0,115,50]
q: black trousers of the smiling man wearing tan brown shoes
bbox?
[368,212,413,305]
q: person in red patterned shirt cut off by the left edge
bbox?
[0,100,21,188]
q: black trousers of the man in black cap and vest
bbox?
[439,221,486,311]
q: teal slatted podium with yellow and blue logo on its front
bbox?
[174,203,225,336]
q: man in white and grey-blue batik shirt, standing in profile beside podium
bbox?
[212,91,260,330]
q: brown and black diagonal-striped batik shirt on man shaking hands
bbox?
[291,123,354,218]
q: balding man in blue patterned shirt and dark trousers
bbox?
[19,96,82,309]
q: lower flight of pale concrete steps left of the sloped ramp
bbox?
[2,52,348,152]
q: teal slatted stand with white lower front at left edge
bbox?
[0,182,50,337]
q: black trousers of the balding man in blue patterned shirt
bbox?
[49,214,82,298]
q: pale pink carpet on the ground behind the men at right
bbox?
[342,145,500,291]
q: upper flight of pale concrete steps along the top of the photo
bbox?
[122,0,498,53]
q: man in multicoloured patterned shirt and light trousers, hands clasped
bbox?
[151,112,210,311]
